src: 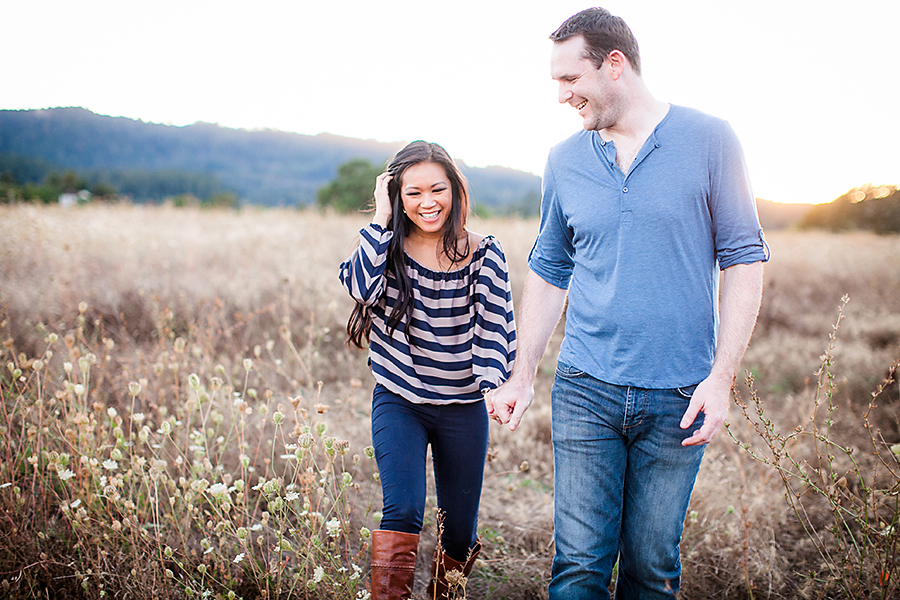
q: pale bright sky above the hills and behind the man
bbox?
[0,0,900,202]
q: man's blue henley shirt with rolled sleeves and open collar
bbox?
[529,105,768,389]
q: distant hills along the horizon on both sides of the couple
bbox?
[0,107,900,233]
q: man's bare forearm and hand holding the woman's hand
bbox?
[485,270,568,431]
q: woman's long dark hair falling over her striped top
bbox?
[347,141,470,348]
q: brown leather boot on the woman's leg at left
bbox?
[372,529,419,600]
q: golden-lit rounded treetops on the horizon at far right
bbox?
[800,184,900,233]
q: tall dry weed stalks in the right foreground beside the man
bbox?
[728,296,900,599]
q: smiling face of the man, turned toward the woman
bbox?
[550,36,623,131]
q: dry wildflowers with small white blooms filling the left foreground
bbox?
[0,303,377,599]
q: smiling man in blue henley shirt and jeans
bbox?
[488,8,768,600]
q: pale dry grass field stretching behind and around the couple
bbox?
[0,205,900,600]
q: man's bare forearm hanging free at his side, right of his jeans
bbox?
[681,262,763,446]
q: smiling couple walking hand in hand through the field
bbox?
[340,8,768,600]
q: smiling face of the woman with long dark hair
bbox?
[400,162,453,237]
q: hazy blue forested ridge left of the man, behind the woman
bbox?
[0,107,540,214]
